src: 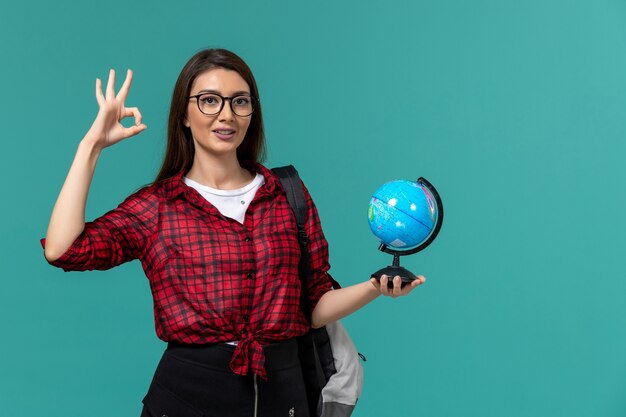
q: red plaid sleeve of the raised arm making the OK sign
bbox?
[40,187,158,272]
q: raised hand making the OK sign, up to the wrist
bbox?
[87,69,146,149]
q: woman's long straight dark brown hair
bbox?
[154,48,265,182]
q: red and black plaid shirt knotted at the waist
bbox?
[41,164,331,378]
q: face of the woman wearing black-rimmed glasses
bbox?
[183,68,252,156]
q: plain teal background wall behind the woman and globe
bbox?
[0,0,626,417]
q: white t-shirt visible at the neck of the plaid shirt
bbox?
[184,172,265,224]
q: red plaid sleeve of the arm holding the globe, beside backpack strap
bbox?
[302,180,333,311]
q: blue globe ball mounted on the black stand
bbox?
[367,180,437,250]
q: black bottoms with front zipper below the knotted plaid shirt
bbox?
[141,339,309,417]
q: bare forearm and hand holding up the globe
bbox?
[311,275,426,328]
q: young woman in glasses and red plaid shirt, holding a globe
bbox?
[41,49,424,417]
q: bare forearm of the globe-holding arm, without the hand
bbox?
[311,281,381,328]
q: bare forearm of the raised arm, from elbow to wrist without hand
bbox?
[44,134,101,261]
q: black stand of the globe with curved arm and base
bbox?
[372,177,443,288]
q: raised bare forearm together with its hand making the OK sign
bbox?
[44,70,146,262]
